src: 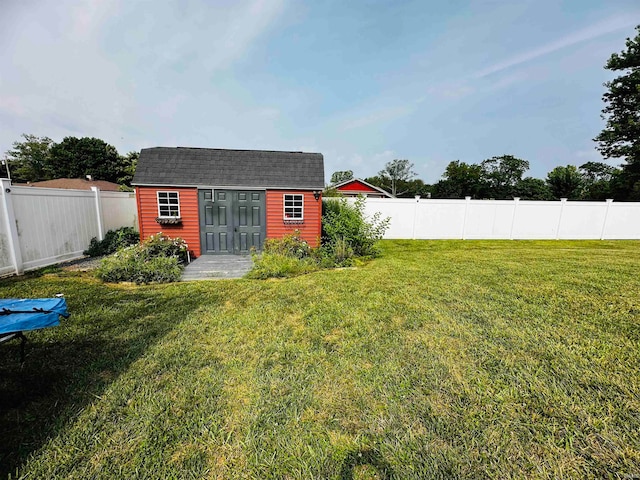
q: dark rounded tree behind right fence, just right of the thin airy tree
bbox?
[432,160,486,198]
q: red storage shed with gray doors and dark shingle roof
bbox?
[132,147,324,256]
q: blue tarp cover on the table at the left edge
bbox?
[0,298,69,334]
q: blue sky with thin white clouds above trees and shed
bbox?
[0,0,640,183]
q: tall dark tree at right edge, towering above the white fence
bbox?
[594,25,640,199]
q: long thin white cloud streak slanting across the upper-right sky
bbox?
[472,16,637,78]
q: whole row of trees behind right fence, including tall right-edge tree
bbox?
[331,25,640,201]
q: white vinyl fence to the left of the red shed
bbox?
[0,179,138,275]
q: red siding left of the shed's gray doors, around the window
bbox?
[136,187,200,256]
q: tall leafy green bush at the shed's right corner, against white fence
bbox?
[322,196,390,258]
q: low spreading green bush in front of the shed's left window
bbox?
[96,233,187,284]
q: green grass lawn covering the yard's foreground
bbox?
[0,241,640,479]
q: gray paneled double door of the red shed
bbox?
[198,189,267,254]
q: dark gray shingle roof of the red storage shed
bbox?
[131,147,324,190]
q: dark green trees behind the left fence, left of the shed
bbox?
[0,137,140,186]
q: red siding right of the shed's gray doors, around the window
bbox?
[267,190,322,247]
